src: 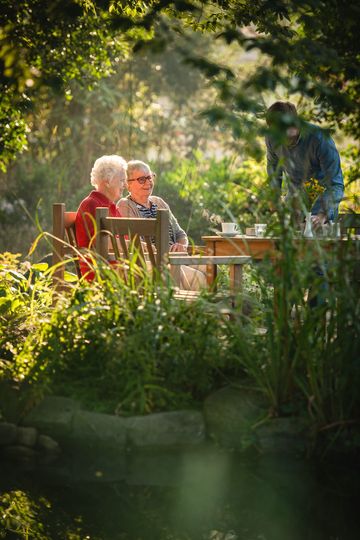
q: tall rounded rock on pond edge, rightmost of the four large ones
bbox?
[204,387,266,450]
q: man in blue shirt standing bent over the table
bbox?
[266,101,344,228]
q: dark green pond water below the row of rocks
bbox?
[0,448,360,540]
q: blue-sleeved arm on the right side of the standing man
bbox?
[311,134,344,221]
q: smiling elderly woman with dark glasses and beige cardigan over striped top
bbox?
[118,160,206,290]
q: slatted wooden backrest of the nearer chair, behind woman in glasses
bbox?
[96,208,169,273]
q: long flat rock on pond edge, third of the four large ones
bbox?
[127,411,205,447]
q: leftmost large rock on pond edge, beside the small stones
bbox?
[22,396,80,440]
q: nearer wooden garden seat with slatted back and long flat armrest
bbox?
[96,208,251,296]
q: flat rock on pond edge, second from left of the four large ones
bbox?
[71,411,127,450]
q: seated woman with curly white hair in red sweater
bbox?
[75,155,127,280]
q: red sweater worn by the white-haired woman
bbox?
[75,190,121,281]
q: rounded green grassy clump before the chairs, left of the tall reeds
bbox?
[14,266,239,413]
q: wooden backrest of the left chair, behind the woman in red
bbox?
[52,203,81,281]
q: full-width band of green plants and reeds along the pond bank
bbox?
[0,219,360,452]
